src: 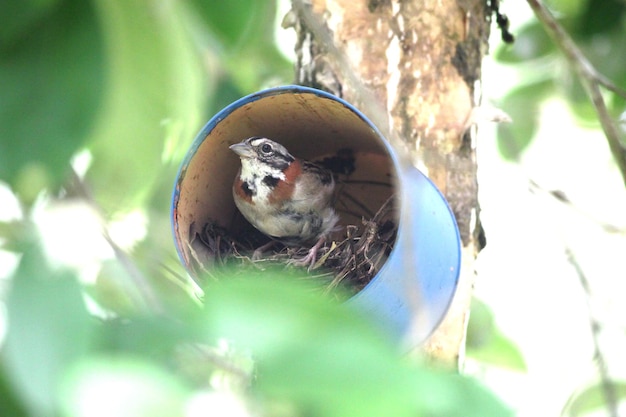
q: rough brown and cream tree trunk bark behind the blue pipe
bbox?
[286,0,490,363]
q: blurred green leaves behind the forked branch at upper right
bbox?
[494,0,626,160]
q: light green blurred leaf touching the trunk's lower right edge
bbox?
[466,299,527,372]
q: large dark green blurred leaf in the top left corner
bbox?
[0,0,103,193]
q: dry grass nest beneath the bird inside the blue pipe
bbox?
[189,196,398,295]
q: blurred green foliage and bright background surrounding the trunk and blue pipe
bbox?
[0,0,626,416]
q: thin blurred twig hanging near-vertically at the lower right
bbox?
[565,246,619,417]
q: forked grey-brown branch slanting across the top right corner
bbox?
[527,0,626,185]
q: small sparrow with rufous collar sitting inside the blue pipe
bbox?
[230,136,339,269]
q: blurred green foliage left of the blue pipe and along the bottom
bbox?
[0,0,508,417]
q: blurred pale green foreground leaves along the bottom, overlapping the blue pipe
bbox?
[0,237,509,417]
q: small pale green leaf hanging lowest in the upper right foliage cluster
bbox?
[498,80,552,160]
